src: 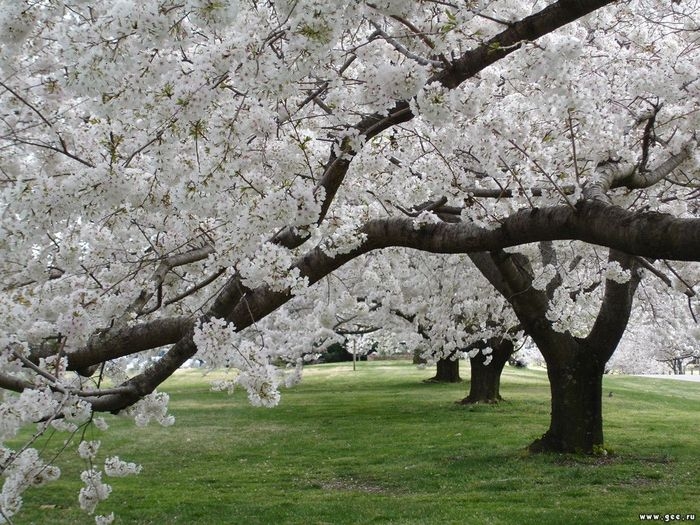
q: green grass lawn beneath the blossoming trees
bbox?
[9,361,700,525]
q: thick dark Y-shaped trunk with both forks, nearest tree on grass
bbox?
[472,250,640,454]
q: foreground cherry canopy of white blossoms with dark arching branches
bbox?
[0,0,700,523]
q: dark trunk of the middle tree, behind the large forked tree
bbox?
[459,339,513,405]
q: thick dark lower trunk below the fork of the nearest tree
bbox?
[529,351,605,454]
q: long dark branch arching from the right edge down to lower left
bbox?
[74,201,700,411]
